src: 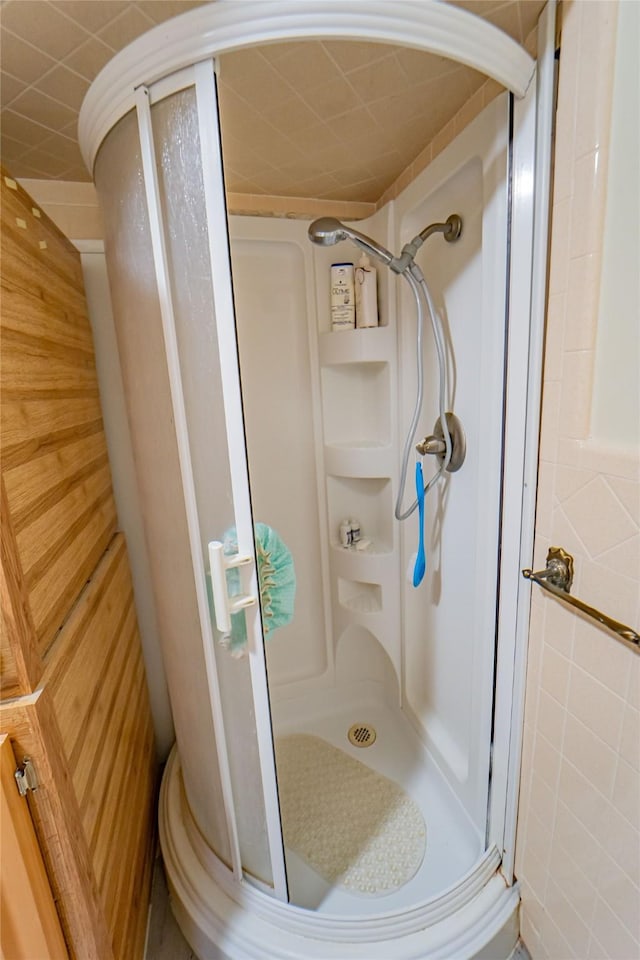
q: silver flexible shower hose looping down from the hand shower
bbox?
[395,263,452,524]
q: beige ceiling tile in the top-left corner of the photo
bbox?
[2,0,87,60]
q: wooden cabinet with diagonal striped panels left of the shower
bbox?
[0,171,156,960]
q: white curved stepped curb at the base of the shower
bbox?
[159,749,520,960]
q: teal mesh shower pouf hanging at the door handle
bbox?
[223,523,296,656]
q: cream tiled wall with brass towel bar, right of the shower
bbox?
[516,0,640,960]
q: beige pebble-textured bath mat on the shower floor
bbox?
[276,734,427,896]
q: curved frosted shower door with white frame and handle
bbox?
[96,62,287,899]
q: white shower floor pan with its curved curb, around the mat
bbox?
[160,688,519,960]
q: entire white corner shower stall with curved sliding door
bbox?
[80,0,554,960]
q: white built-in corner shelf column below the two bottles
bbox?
[318,300,400,677]
